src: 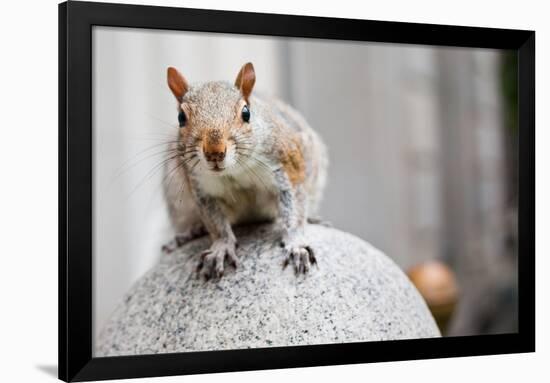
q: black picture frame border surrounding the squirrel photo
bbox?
[59,1,535,381]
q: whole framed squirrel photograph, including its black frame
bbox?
[59,1,535,381]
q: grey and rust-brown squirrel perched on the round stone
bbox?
[163,63,328,280]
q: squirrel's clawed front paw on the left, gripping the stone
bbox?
[197,240,238,280]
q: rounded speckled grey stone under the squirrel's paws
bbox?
[95,225,440,356]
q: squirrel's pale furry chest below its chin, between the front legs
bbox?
[199,168,278,224]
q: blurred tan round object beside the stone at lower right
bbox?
[407,261,458,334]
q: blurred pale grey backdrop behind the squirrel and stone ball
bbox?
[92,27,518,352]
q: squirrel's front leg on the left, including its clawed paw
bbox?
[193,196,238,280]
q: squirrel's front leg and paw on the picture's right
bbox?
[276,171,317,274]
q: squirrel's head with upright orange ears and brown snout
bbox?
[168,63,256,174]
